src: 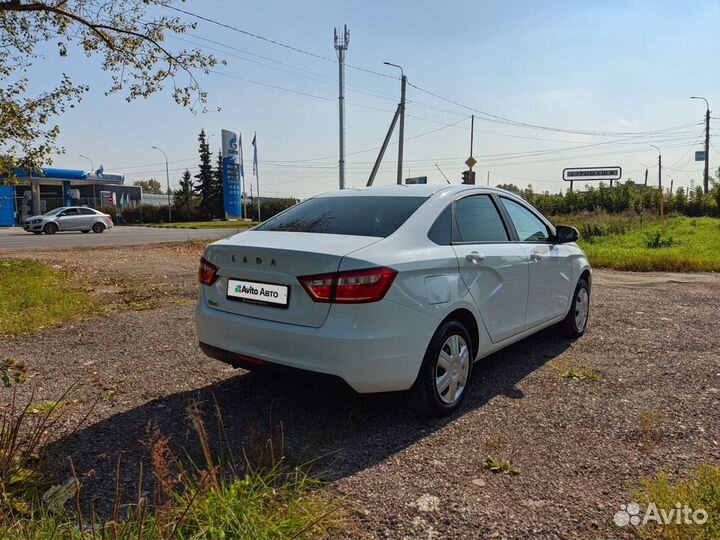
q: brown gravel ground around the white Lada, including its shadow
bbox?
[0,245,720,539]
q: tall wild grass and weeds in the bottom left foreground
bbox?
[0,394,342,540]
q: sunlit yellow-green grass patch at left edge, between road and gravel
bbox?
[0,259,100,335]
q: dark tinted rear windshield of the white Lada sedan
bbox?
[255,196,427,238]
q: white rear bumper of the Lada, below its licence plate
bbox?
[195,292,440,393]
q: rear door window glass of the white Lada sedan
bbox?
[455,195,508,242]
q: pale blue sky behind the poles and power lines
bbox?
[38,0,720,197]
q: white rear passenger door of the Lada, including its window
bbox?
[453,194,528,343]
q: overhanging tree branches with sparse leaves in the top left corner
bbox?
[0,0,218,174]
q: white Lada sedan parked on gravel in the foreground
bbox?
[196,185,591,416]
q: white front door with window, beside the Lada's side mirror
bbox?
[500,197,573,328]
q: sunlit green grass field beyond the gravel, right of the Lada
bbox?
[557,216,720,272]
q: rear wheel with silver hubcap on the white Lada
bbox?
[410,320,475,418]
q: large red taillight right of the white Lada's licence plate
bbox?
[298,267,397,304]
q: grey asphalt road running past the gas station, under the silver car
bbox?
[0,226,238,253]
